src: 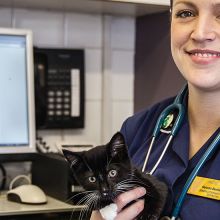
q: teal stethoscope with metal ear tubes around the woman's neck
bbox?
[142,86,220,220]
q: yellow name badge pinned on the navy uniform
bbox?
[187,176,220,200]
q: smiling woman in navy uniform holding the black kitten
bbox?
[91,0,220,220]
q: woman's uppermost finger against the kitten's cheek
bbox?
[115,187,146,212]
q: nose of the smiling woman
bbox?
[191,16,219,42]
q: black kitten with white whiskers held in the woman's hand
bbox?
[63,132,167,220]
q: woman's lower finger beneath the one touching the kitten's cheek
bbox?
[114,200,144,220]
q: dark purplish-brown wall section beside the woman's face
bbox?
[134,12,185,112]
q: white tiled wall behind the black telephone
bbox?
[0,8,135,150]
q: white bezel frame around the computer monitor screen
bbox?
[0,28,36,154]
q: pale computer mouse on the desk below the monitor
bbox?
[7,184,47,205]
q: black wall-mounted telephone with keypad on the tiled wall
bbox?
[34,48,85,129]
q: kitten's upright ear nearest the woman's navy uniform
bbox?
[109,132,128,158]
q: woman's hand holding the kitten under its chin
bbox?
[90,187,146,220]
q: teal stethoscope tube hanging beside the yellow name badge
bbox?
[171,133,220,220]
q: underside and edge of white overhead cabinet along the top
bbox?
[0,0,170,16]
